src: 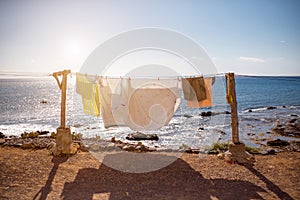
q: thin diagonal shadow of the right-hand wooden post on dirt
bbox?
[244,164,293,200]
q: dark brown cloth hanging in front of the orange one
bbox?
[182,77,207,101]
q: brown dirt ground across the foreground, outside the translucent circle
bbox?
[0,147,300,200]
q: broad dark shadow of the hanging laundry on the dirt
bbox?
[61,153,266,200]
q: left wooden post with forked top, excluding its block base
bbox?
[53,70,71,128]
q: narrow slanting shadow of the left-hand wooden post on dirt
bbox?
[33,155,69,200]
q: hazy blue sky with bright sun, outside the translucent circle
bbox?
[0,0,300,75]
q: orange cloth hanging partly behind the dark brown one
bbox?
[187,78,213,108]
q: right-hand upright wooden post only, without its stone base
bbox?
[226,73,240,144]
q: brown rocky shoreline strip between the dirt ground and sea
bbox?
[0,115,300,155]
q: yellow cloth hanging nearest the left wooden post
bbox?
[76,73,100,116]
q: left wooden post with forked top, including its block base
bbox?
[53,70,77,155]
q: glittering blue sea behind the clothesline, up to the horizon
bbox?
[0,75,300,149]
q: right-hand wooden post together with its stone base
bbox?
[225,73,254,163]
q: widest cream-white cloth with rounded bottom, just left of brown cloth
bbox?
[127,80,180,131]
